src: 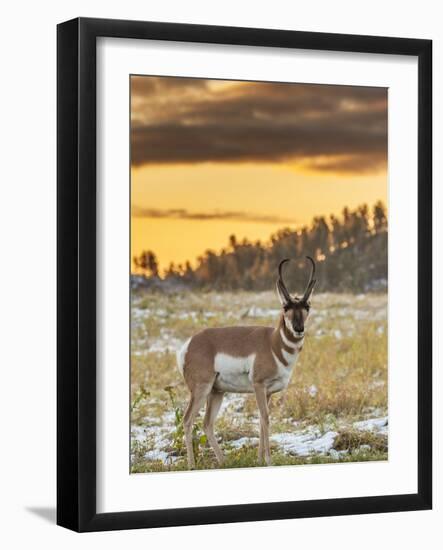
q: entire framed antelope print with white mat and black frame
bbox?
[57,18,432,531]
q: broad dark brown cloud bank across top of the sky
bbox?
[131,77,387,172]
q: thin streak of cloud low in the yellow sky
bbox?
[131,206,296,223]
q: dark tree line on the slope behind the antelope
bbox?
[134,201,388,292]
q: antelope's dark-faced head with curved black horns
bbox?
[277,256,317,338]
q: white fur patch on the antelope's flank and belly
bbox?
[214,353,255,393]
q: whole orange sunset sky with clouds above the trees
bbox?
[131,76,387,269]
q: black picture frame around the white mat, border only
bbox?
[57,18,432,531]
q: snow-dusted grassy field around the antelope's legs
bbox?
[131,291,388,473]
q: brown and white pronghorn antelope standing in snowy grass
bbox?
[177,256,316,468]
